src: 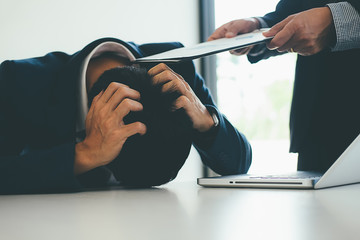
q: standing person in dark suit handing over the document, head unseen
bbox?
[209,0,360,172]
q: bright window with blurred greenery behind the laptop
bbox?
[214,0,297,172]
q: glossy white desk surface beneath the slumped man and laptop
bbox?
[0,182,360,240]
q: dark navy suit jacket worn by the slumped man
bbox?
[0,38,251,193]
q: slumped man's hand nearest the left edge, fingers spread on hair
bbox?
[74,82,146,175]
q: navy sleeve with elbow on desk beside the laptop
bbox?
[187,65,252,175]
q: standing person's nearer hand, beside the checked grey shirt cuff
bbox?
[264,7,336,56]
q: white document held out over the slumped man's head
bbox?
[134,28,272,63]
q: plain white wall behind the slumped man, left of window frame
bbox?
[0,0,201,181]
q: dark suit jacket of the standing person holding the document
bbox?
[248,0,360,172]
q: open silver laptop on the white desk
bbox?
[197,135,360,189]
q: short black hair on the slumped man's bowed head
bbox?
[88,66,192,187]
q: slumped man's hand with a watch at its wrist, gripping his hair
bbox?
[148,63,214,132]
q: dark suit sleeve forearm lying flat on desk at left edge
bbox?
[0,141,80,194]
